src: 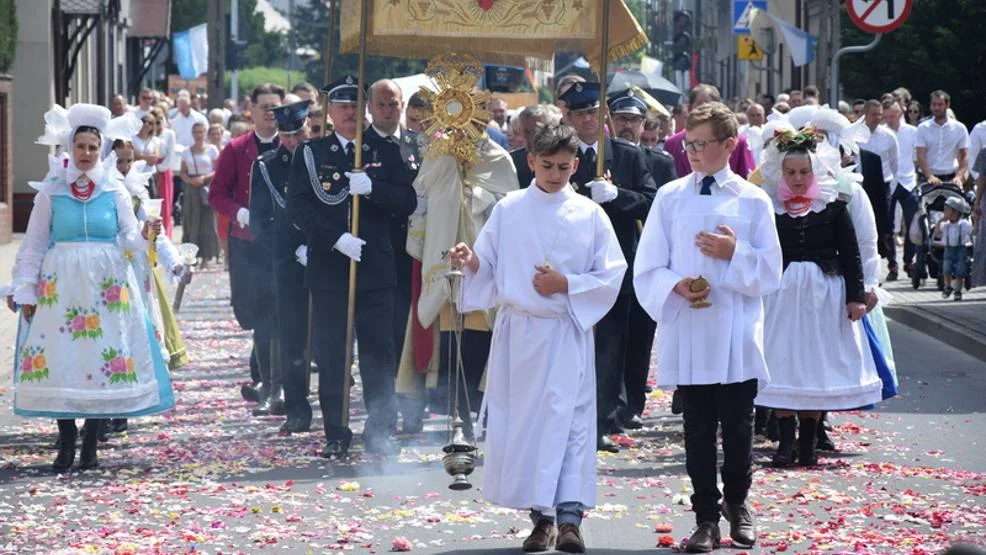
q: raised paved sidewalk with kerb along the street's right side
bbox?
[882,263,986,360]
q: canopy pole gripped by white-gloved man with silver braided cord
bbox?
[342,0,370,428]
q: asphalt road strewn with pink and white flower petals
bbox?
[0,273,986,555]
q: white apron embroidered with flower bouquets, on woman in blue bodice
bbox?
[14,242,165,418]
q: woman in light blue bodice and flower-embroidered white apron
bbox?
[8,104,175,471]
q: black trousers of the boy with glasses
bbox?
[678,380,757,523]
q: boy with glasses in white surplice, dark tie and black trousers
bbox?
[633,102,783,553]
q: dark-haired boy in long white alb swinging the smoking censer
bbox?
[450,124,627,553]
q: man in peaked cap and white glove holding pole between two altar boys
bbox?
[561,83,657,452]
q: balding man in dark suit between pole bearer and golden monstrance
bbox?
[363,79,426,434]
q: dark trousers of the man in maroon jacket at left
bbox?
[229,237,277,382]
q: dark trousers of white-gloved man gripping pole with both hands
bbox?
[312,288,397,440]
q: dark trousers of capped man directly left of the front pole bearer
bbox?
[274,259,312,418]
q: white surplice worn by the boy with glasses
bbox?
[633,172,783,389]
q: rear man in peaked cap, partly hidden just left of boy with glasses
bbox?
[608,89,678,430]
